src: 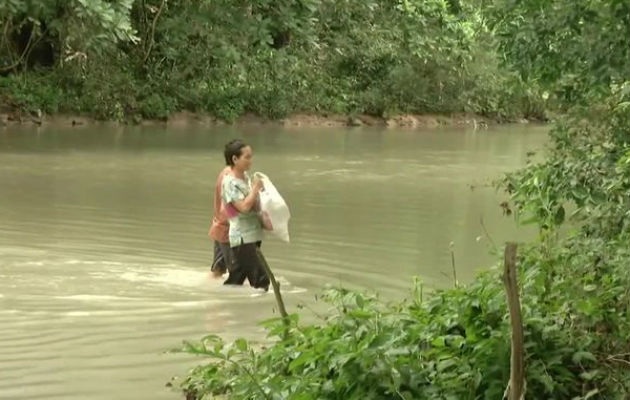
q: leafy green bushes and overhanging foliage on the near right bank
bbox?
[165,0,630,399]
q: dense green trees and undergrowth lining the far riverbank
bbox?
[0,0,630,120]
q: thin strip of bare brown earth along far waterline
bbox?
[0,110,533,129]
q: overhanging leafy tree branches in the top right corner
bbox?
[488,0,630,104]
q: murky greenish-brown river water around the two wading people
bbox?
[0,125,547,400]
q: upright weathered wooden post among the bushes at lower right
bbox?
[503,242,525,400]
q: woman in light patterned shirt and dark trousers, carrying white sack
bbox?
[221,140,269,290]
